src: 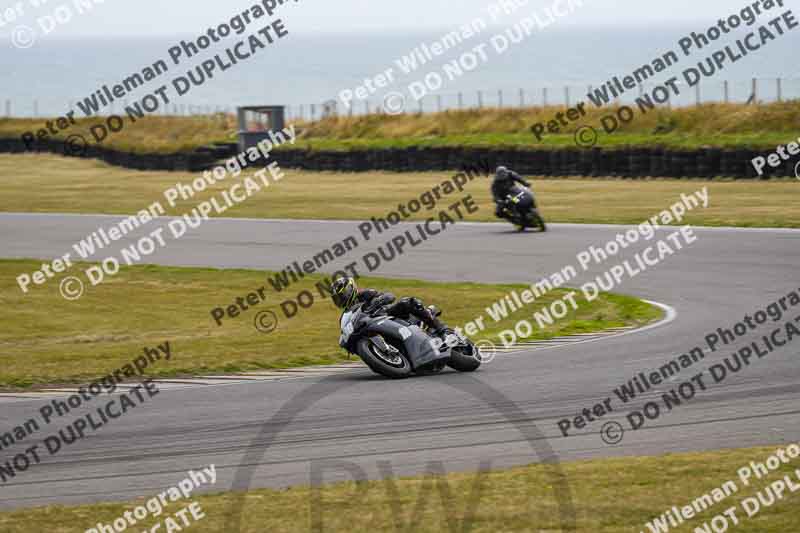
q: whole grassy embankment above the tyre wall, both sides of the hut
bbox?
[0,101,800,153]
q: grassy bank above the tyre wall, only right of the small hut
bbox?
[287,101,800,150]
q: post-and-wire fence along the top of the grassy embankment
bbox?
[4,78,800,121]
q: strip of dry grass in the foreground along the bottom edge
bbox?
[0,446,800,533]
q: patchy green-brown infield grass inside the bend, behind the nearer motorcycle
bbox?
[0,260,661,388]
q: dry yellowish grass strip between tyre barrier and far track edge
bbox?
[0,154,800,228]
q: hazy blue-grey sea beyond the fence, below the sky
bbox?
[0,26,800,117]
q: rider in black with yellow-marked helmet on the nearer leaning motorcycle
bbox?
[331,278,452,338]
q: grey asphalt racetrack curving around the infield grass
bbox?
[0,214,800,509]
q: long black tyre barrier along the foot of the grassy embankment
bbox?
[0,138,796,179]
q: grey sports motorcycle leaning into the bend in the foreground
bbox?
[339,305,481,378]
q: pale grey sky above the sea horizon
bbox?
[0,0,764,37]
